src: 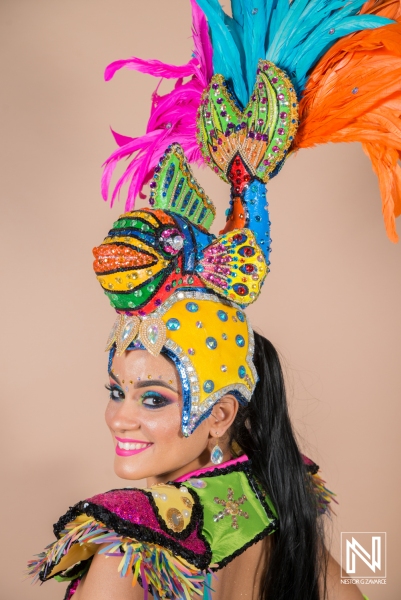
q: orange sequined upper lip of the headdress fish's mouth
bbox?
[93,244,156,273]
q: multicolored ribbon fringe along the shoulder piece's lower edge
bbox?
[28,517,207,600]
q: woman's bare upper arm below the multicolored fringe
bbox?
[74,553,143,600]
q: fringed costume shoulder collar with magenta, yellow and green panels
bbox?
[29,455,333,600]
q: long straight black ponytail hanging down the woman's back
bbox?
[232,333,326,600]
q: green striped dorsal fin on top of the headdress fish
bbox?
[150,144,215,230]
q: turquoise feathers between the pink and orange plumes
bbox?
[196,0,392,107]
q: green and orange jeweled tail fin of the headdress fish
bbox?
[197,60,298,182]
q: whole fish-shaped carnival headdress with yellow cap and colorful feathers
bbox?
[94,0,401,435]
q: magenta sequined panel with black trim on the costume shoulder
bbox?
[87,489,206,554]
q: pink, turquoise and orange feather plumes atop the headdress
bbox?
[102,0,401,241]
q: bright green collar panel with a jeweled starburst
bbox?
[183,471,275,564]
